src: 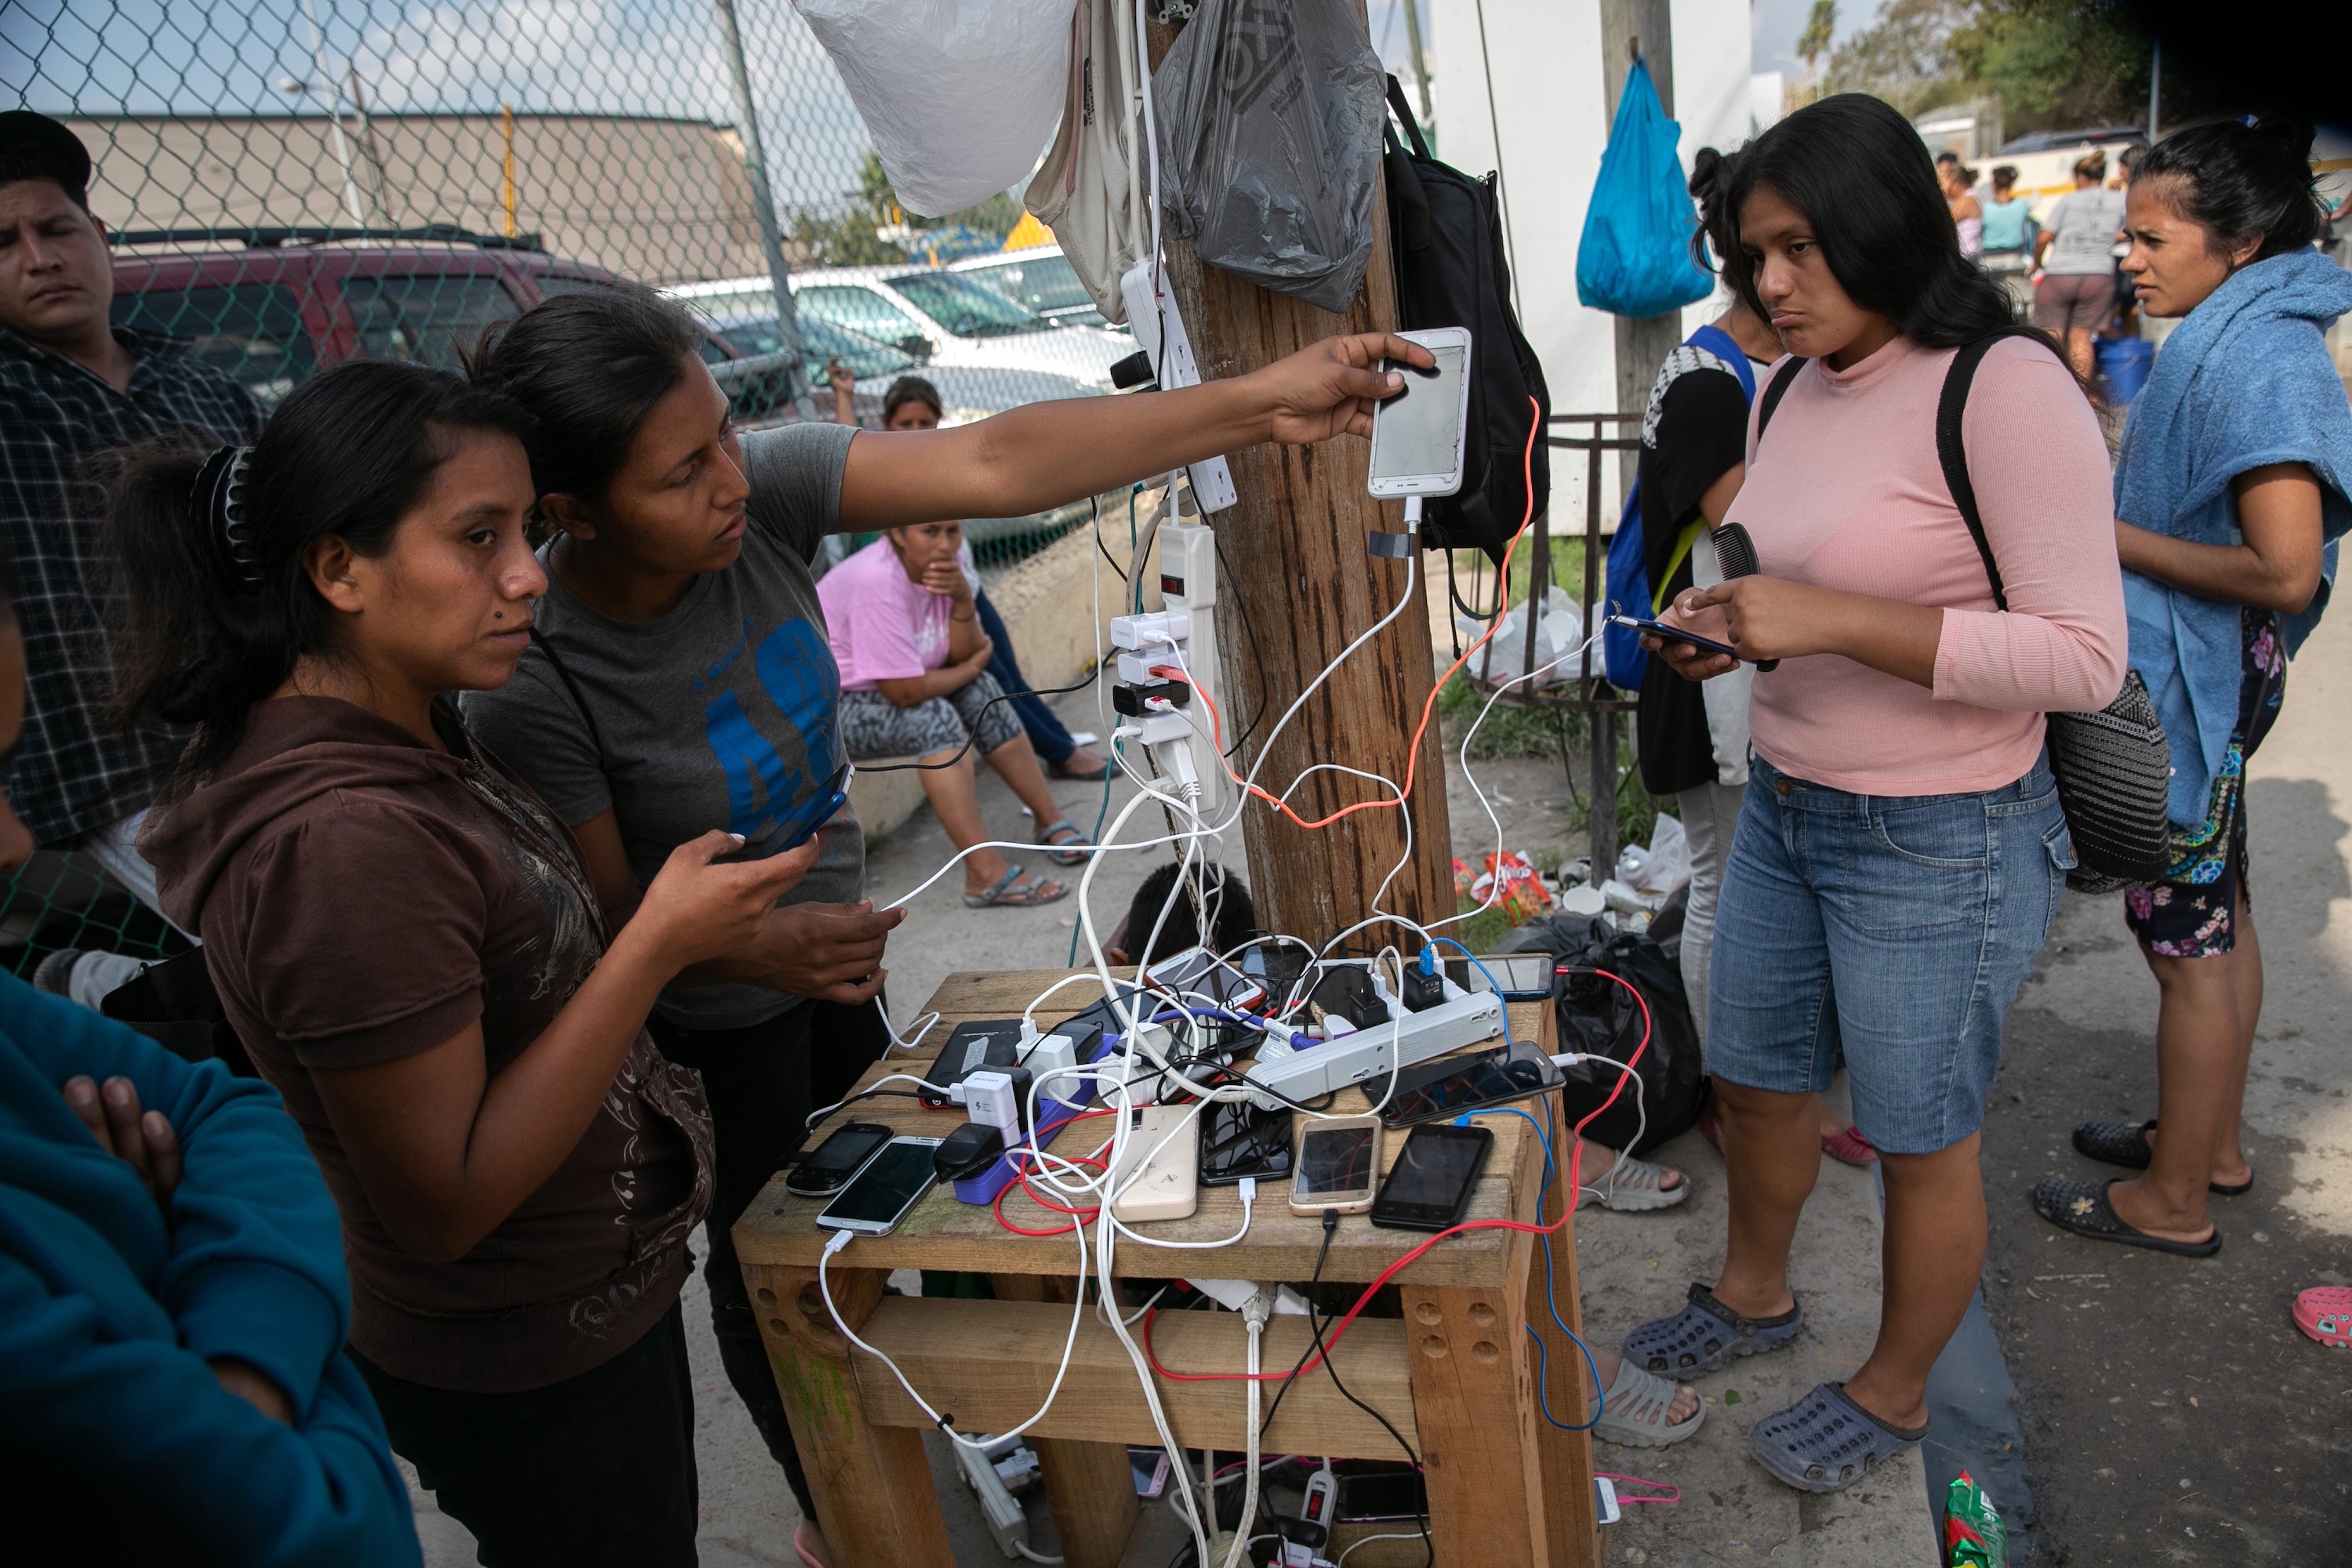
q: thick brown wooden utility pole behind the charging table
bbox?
[1150,7,1454,945]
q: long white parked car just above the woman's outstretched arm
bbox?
[675,266,1134,393]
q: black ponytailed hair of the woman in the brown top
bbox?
[106,360,529,787]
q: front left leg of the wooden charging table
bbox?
[743,1262,955,1568]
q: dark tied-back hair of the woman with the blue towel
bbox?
[2136,115,2324,261]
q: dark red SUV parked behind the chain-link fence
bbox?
[113,223,797,426]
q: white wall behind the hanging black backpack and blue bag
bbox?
[1428,0,1750,532]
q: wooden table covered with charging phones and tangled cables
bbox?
[734,968,1604,1568]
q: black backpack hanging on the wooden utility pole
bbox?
[1383,78,1552,562]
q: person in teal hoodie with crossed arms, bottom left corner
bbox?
[0,586,421,1568]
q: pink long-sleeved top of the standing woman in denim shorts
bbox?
[1729,339,2126,794]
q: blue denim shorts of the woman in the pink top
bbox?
[1708,757,2074,1154]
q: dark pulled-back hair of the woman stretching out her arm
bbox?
[466,287,706,512]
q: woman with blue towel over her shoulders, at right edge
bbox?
[2034,120,2352,1258]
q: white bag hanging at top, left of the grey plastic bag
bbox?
[793,0,1070,219]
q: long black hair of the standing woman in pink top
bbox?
[1724,92,2016,348]
